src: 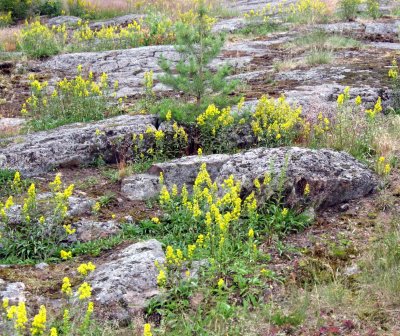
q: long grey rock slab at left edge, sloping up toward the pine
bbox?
[0,115,157,176]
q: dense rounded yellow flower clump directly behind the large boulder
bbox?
[251,96,304,142]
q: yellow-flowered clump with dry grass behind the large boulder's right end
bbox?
[307,87,400,175]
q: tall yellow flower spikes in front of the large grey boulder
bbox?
[156,163,266,287]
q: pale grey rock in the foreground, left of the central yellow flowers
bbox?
[88,239,165,324]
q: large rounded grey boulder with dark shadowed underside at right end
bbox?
[122,147,377,208]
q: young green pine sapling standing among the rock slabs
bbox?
[159,2,237,121]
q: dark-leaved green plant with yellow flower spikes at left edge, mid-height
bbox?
[0,175,74,260]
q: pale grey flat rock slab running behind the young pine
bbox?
[37,41,255,97]
